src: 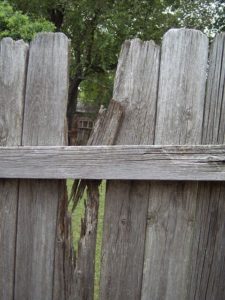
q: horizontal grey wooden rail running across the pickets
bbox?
[0,145,225,181]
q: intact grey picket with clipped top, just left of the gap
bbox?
[14,33,68,300]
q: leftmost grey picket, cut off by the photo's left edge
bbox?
[0,38,28,300]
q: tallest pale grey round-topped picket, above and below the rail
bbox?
[142,29,208,300]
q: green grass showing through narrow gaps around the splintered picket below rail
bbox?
[67,180,106,300]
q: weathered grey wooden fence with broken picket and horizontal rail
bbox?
[0,29,225,300]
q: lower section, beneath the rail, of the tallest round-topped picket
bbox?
[142,181,198,300]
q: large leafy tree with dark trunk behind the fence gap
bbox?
[5,0,225,128]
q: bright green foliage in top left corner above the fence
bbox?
[0,1,55,41]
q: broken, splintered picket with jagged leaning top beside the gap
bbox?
[70,100,123,300]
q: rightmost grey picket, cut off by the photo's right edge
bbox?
[189,33,225,300]
